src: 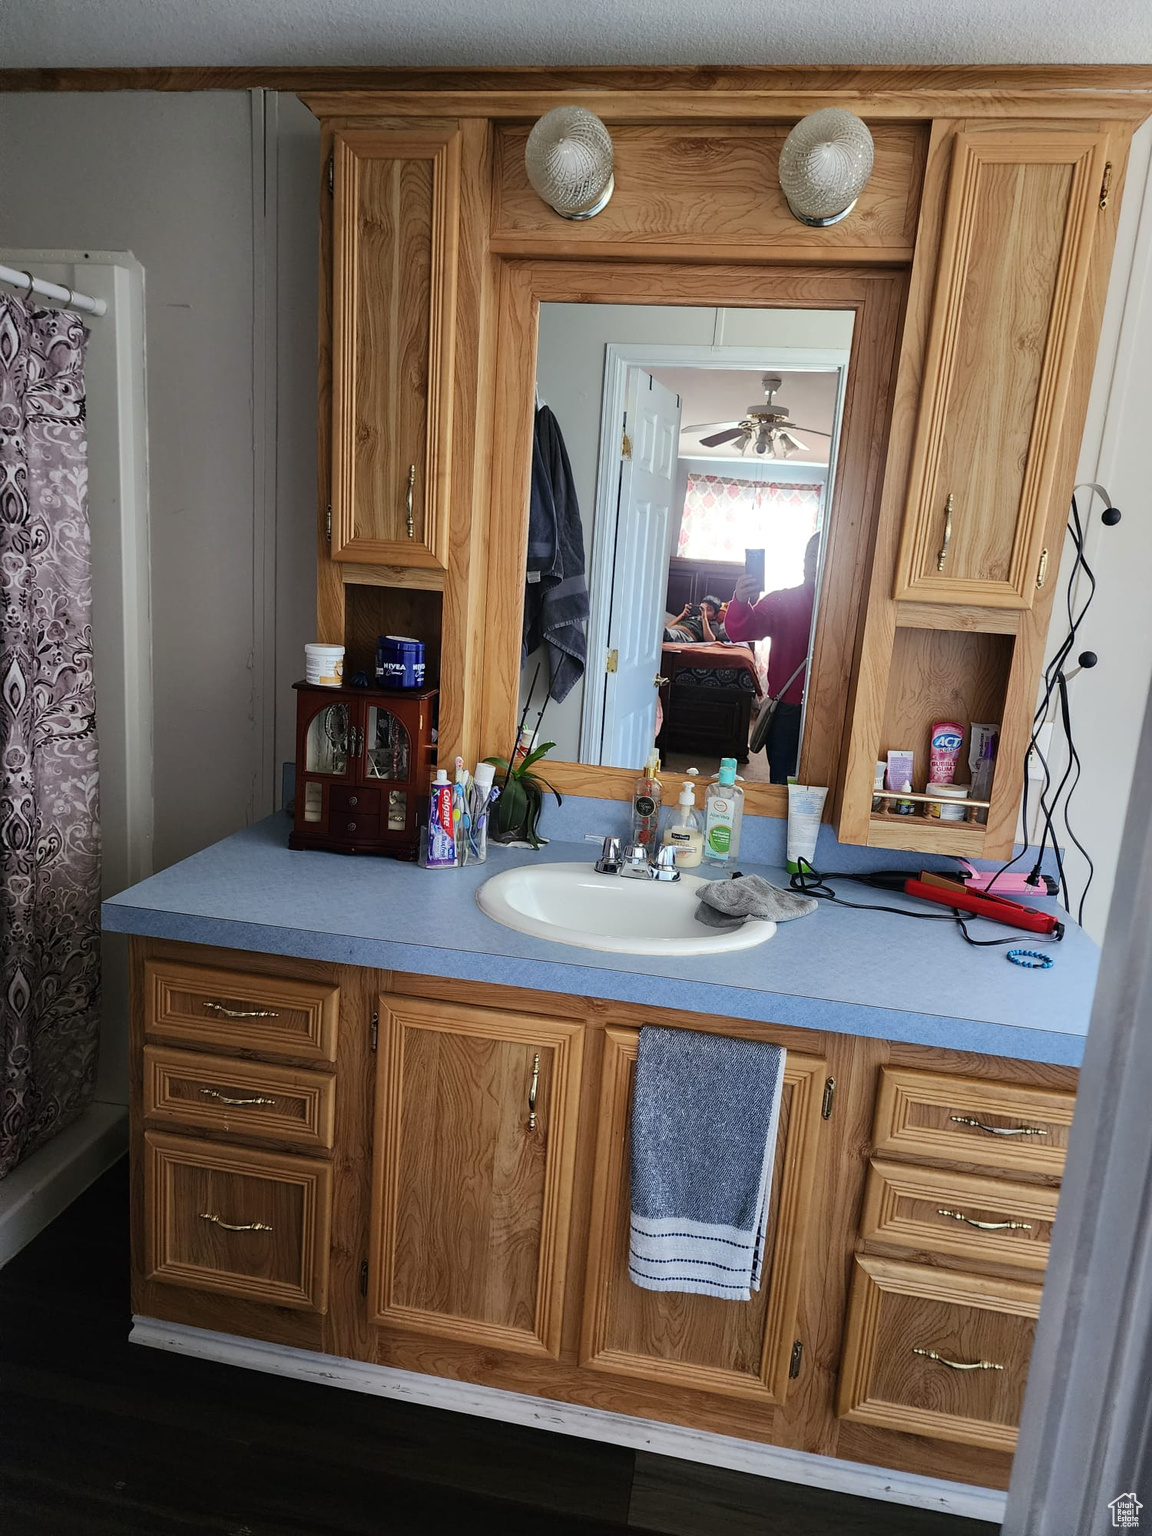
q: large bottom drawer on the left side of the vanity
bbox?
[144,1130,332,1312]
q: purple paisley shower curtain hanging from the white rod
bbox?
[0,296,100,1177]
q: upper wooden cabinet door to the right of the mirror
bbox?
[894,123,1107,608]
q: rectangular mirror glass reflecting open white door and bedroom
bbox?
[521,303,856,783]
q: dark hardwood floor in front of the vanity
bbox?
[0,1163,995,1536]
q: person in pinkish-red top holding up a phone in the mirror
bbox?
[723,533,820,783]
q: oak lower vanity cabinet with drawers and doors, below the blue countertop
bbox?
[132,940,1075,1487]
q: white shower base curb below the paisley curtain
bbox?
[0,1103,127,1269]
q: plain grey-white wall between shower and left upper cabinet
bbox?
[0,91,316,868]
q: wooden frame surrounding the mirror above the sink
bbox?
[479,260,908,819]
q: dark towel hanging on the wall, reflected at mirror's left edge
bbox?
[521,406,588,703]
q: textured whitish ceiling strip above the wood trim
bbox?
[0,0,1152,68]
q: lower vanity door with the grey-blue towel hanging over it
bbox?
[581,1028,826,1405]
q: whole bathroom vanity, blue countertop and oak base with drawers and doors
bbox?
[104,816,1097,1518]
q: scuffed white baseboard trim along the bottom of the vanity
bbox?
[131,1316,1005,1525]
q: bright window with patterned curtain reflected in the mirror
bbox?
[676,475,823,591]
